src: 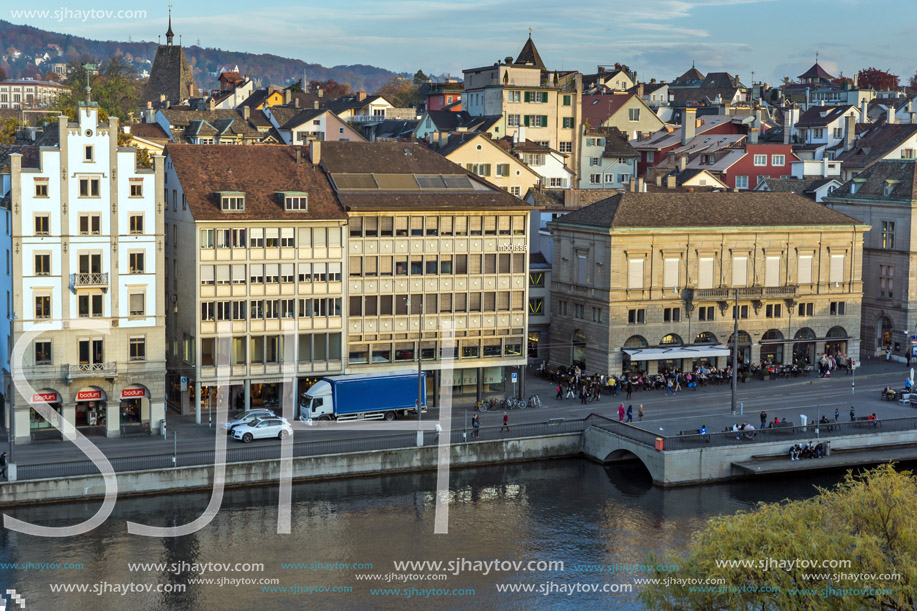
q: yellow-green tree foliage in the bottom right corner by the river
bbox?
[640,465,917,611]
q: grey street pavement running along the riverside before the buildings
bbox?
[13,359,917,464]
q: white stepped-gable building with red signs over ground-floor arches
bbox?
[10,102,165,443]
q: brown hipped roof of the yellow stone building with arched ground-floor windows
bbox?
[554,191,860,229]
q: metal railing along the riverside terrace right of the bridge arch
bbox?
[664,417,917,450]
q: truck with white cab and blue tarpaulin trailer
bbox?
[299,371,427,421]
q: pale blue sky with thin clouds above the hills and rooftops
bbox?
[7,0,917,85]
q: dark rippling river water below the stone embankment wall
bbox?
[0,459,860,610]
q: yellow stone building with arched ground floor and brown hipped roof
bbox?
[549,191,869,373]
